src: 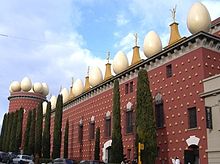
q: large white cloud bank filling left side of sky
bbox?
[0,1,105,123]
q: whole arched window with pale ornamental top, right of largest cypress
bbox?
[155,93,164,128]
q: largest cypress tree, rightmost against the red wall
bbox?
[136,70,157,164]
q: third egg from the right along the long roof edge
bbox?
[112,51,128,74]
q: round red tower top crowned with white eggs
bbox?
[8,77,49,113]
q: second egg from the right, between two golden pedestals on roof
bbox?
[144,31,162,57]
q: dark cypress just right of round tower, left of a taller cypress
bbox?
[42,102,51,158]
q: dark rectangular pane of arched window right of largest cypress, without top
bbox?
[155,102,164,128]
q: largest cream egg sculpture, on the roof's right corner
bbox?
[187,2,211,34]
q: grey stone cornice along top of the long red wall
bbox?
[64,31,220,110]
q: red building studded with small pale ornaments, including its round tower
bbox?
[9,8,220,164]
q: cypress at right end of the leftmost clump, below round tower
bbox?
[15,108,24,153]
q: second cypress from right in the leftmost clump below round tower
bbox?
[9,110,18,152]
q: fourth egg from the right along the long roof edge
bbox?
[89,67,103,87]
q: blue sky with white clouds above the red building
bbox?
[0,0,220,124]
